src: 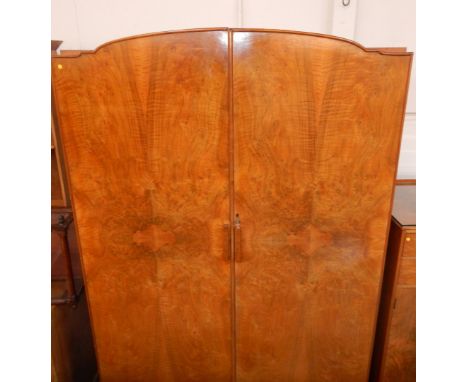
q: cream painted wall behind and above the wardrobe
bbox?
[52,0,416,178]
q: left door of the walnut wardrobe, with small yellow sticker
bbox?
[52,29,232,382]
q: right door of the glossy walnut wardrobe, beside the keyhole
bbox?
[232,30,412,382]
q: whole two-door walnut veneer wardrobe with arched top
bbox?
[52,28,412,382]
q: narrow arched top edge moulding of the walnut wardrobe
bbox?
[52,27,413,59]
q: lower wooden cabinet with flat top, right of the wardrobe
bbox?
[371,184,416,382]
